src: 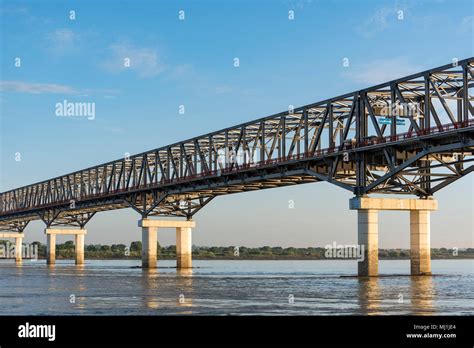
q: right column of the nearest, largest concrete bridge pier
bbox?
[410,210,431,275]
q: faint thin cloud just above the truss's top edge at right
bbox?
[343,57,421,85]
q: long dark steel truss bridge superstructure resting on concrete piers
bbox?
[0,58,474,232]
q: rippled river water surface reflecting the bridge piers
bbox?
[0,260,474,315]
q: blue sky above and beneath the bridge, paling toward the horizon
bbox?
[0,0,474,247]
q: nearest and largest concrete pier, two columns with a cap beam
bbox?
[349,197,438,277]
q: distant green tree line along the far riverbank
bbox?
[0,240,474,260]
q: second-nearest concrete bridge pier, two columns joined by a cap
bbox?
[138,219,196,269]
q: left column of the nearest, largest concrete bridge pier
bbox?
[357,209,379,277]
